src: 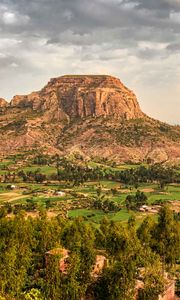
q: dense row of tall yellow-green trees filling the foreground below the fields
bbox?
[0,207,180,300]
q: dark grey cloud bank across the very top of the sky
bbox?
[0,0,180,58]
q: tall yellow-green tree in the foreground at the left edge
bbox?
[0,214,32,298]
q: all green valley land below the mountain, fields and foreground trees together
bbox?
[0,153,180,300]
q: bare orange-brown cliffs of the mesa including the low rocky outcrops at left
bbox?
[7,75,144,120]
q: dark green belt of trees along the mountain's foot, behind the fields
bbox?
[0,155,180,189]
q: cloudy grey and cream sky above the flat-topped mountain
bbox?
[0,0,180,123]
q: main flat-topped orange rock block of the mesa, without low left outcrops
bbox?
[41,75,144,119]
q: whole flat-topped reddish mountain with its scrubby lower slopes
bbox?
[0,75,180,163]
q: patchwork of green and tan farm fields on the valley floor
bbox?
[0,152,180,224]
